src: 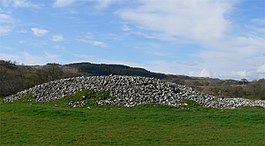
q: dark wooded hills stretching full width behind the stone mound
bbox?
[0,60,265,100]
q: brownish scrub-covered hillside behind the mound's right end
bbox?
[166,75,265,100]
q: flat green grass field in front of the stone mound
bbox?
[0,91,265,146]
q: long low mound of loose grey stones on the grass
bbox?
[4,75,265,108]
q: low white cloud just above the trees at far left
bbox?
[0,52,60,65]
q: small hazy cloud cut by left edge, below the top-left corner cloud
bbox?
[0,11,16,36]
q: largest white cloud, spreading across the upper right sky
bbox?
[116,0,265,78]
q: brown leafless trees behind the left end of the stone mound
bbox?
[0,61,78,97]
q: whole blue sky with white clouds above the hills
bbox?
[0,0,265,80]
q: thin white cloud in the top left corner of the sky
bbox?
[2,0,38,8]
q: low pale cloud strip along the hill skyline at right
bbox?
[123,60,260,80]
